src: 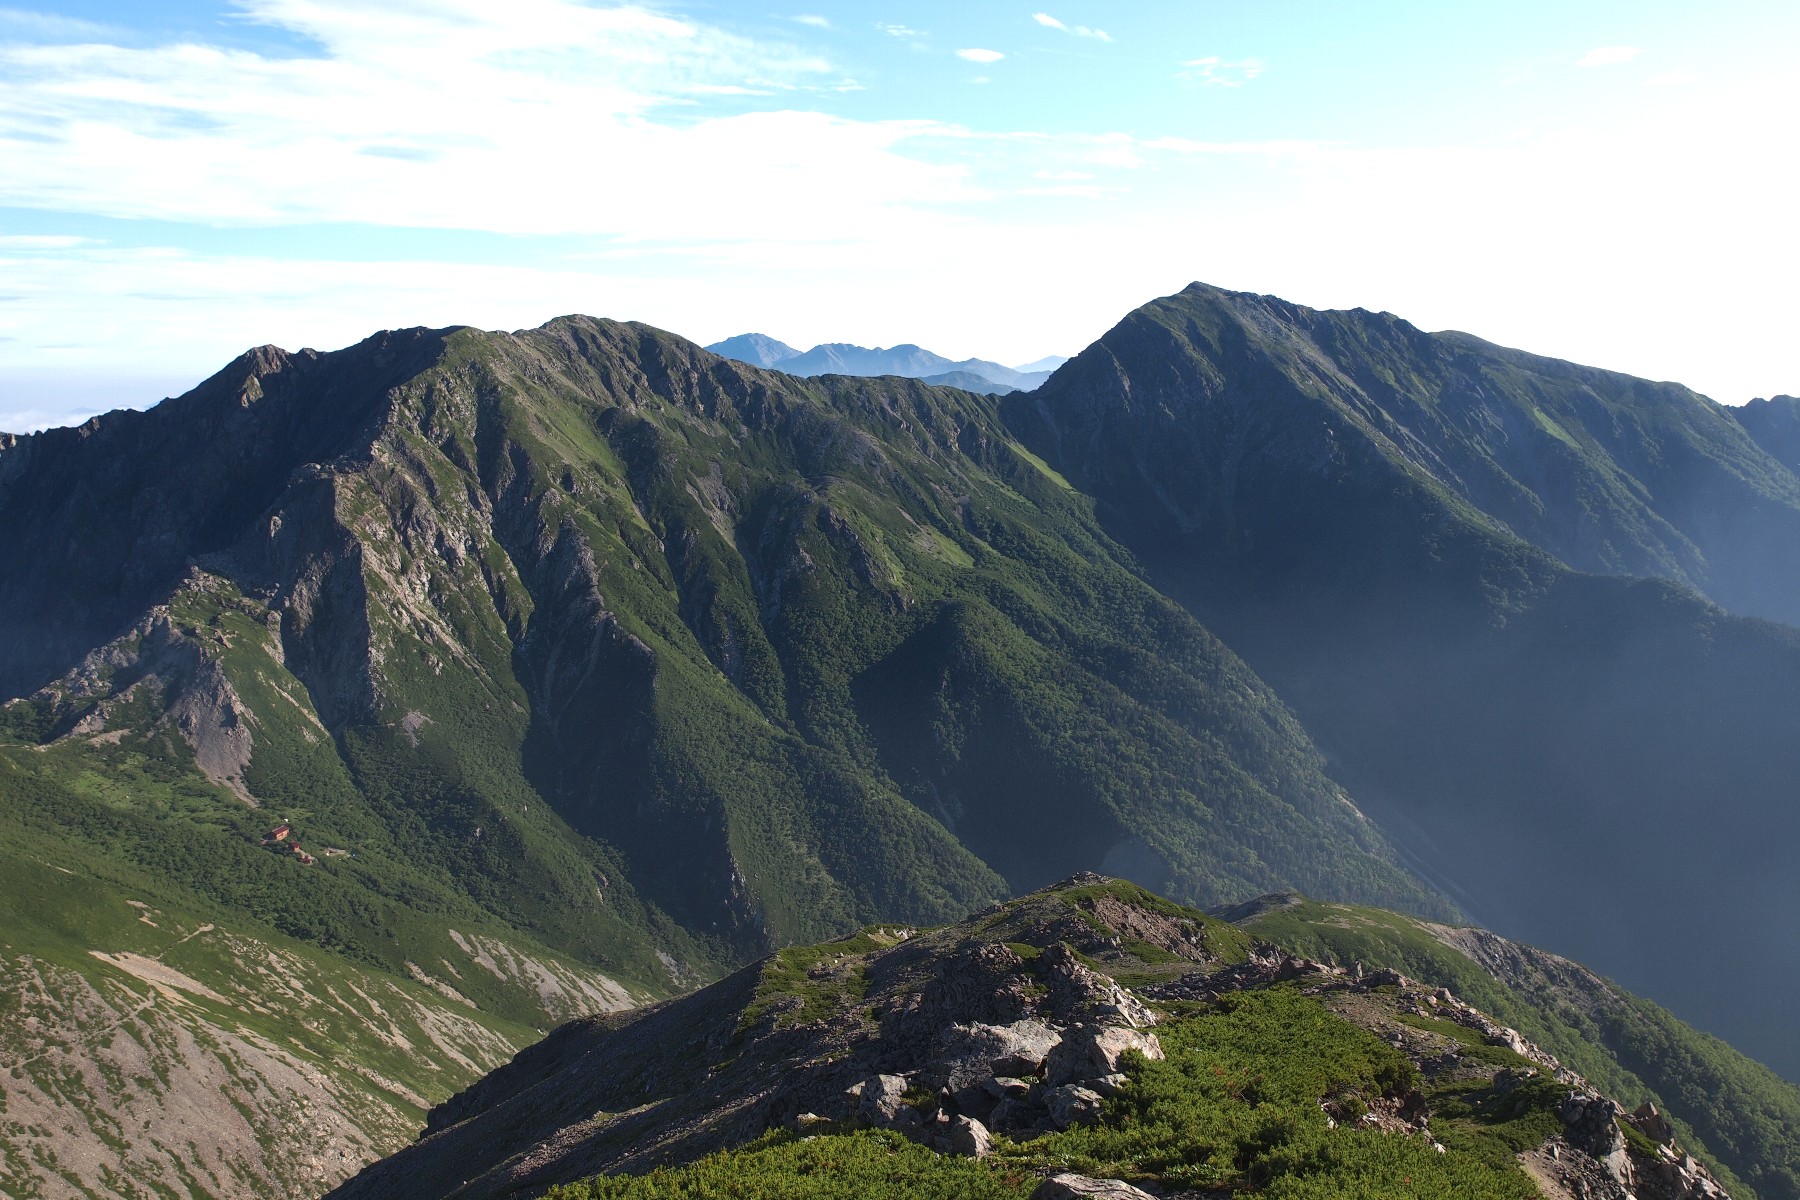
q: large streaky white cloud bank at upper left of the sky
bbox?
[0,0,993,241]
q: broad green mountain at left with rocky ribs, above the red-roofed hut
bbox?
[0,318,1453,1193]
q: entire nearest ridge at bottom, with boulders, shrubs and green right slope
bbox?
[333,874,1800,1200]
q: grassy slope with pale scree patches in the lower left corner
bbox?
[0,788,544,1200]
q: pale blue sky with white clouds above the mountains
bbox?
[0,0,1800,432]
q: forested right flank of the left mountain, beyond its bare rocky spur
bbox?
[369,320,1433,945]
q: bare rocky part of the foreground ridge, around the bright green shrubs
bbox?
[331,874,1728,1200]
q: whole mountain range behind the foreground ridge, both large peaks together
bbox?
[0,288,1800,1191]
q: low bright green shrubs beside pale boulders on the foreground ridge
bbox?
[551,988,1566,1200]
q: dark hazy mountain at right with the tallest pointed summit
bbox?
[1006,286,1800,1076]
